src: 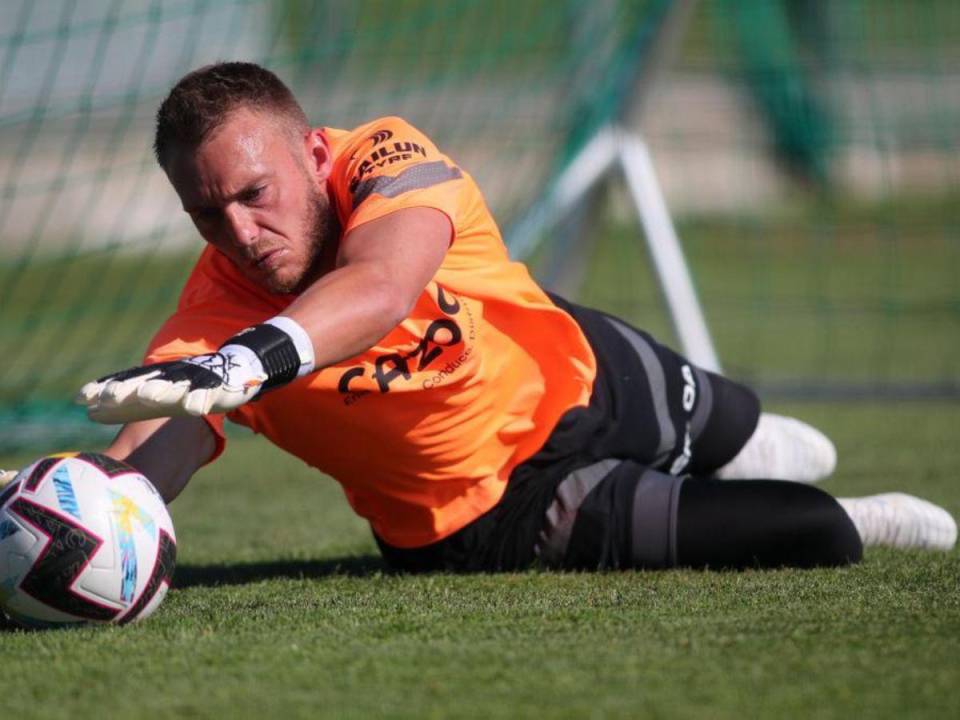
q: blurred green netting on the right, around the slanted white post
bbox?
[541,0,960,397]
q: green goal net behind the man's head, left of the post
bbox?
[0,0,669,438]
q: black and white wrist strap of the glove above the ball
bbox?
[220,315,313,393]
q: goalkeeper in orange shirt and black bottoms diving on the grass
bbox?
[58,63,956,570]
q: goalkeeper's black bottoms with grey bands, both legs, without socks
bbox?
[377,296,862,572]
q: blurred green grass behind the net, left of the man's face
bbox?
[0,246,200,408]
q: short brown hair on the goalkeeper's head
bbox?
[153,62,309,168]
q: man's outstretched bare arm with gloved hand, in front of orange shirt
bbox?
[77,207,453,423]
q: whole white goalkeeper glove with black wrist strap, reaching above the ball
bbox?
[76,316,313,424]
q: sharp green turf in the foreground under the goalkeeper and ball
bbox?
[0,403,960,719]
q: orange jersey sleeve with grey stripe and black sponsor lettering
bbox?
[330,117,465,233]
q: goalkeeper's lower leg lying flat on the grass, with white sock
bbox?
[378,458,957,572]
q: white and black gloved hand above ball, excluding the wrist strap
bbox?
[77,350,267,424]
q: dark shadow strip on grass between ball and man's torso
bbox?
[173,555,391,589]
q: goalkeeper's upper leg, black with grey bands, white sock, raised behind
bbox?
[552,296,836,482]
